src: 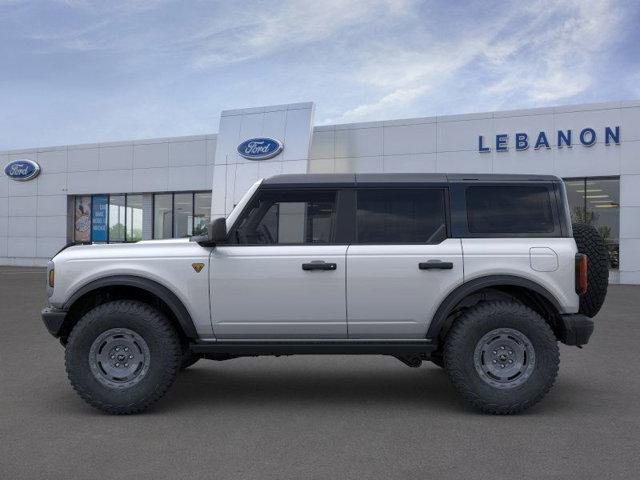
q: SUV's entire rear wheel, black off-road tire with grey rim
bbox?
[444,301,560,415]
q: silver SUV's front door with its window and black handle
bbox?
[210,189,347,339]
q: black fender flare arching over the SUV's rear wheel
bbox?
[427,275,562,339]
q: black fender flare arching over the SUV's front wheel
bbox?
[63,275,198,340]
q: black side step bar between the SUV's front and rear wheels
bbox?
[190,340,436,357]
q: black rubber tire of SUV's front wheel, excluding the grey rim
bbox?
[65,300,182,414]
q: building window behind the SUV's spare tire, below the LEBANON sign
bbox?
[565,177,620,269]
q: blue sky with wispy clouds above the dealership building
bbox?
[0,0,640,150]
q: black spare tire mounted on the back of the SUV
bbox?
[573,223,609,317]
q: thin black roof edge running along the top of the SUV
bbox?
[263,173,560,187]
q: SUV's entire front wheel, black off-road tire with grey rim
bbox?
[65,300,182,414]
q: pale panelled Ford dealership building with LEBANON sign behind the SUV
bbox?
[0,101,640,284]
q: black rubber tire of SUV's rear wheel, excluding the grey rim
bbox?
[444,301,560,415]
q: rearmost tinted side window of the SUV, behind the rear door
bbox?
[466,185,556,234]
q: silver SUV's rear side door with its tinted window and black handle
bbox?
[347,188,463,338]
